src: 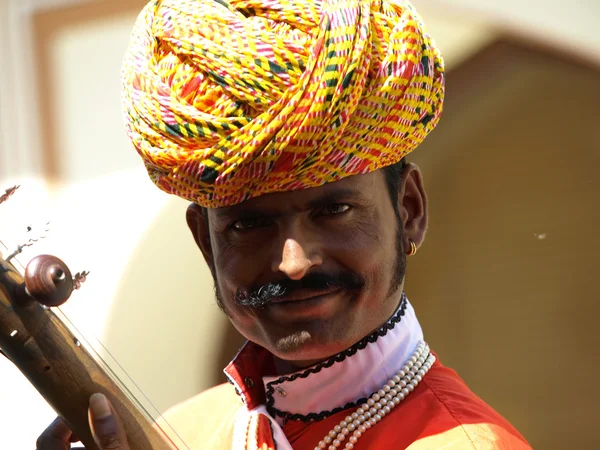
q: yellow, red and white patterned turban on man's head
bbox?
[122,0,444,208]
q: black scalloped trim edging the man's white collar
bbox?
[265,292,407,423]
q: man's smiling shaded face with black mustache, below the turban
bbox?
[188,167,420,366]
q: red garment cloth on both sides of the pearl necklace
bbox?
[284,356,531,450]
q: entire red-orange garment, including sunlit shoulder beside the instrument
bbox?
[163,354,531,450]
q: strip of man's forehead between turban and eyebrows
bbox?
[212,170,383,217]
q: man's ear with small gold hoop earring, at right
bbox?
[398,163,428,248]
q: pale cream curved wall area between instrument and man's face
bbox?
[103,198,243,412]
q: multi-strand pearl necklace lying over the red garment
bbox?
[315,341,435,450]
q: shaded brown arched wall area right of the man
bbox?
[407,41,600,450]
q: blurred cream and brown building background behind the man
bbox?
[0,0,600,450]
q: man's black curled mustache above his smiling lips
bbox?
[235,272,365,308]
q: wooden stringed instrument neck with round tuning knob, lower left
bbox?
[0,186,183,450]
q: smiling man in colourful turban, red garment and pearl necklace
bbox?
[38,0,529,450]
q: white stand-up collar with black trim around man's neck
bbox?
[262,296,423,424]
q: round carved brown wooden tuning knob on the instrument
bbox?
[25,255,73,306]
